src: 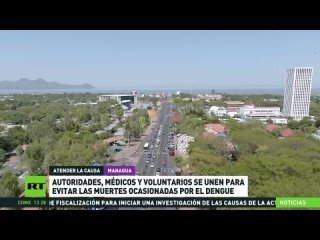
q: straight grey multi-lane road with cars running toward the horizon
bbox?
[136,100,176,176]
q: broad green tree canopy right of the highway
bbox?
[175,95,320,197]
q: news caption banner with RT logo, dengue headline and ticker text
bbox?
[14,166,275,209]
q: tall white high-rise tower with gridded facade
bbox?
[283,67,313,120]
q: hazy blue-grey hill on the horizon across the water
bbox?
[0,78,94,90]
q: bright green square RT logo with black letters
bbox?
[24,176,47,197]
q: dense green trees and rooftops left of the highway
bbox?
[0,93,123,175]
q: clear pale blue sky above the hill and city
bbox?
[0,30,320,90]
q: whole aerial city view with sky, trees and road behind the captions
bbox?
[0,31,320,209]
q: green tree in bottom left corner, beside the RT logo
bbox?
[0,172,20,197]
